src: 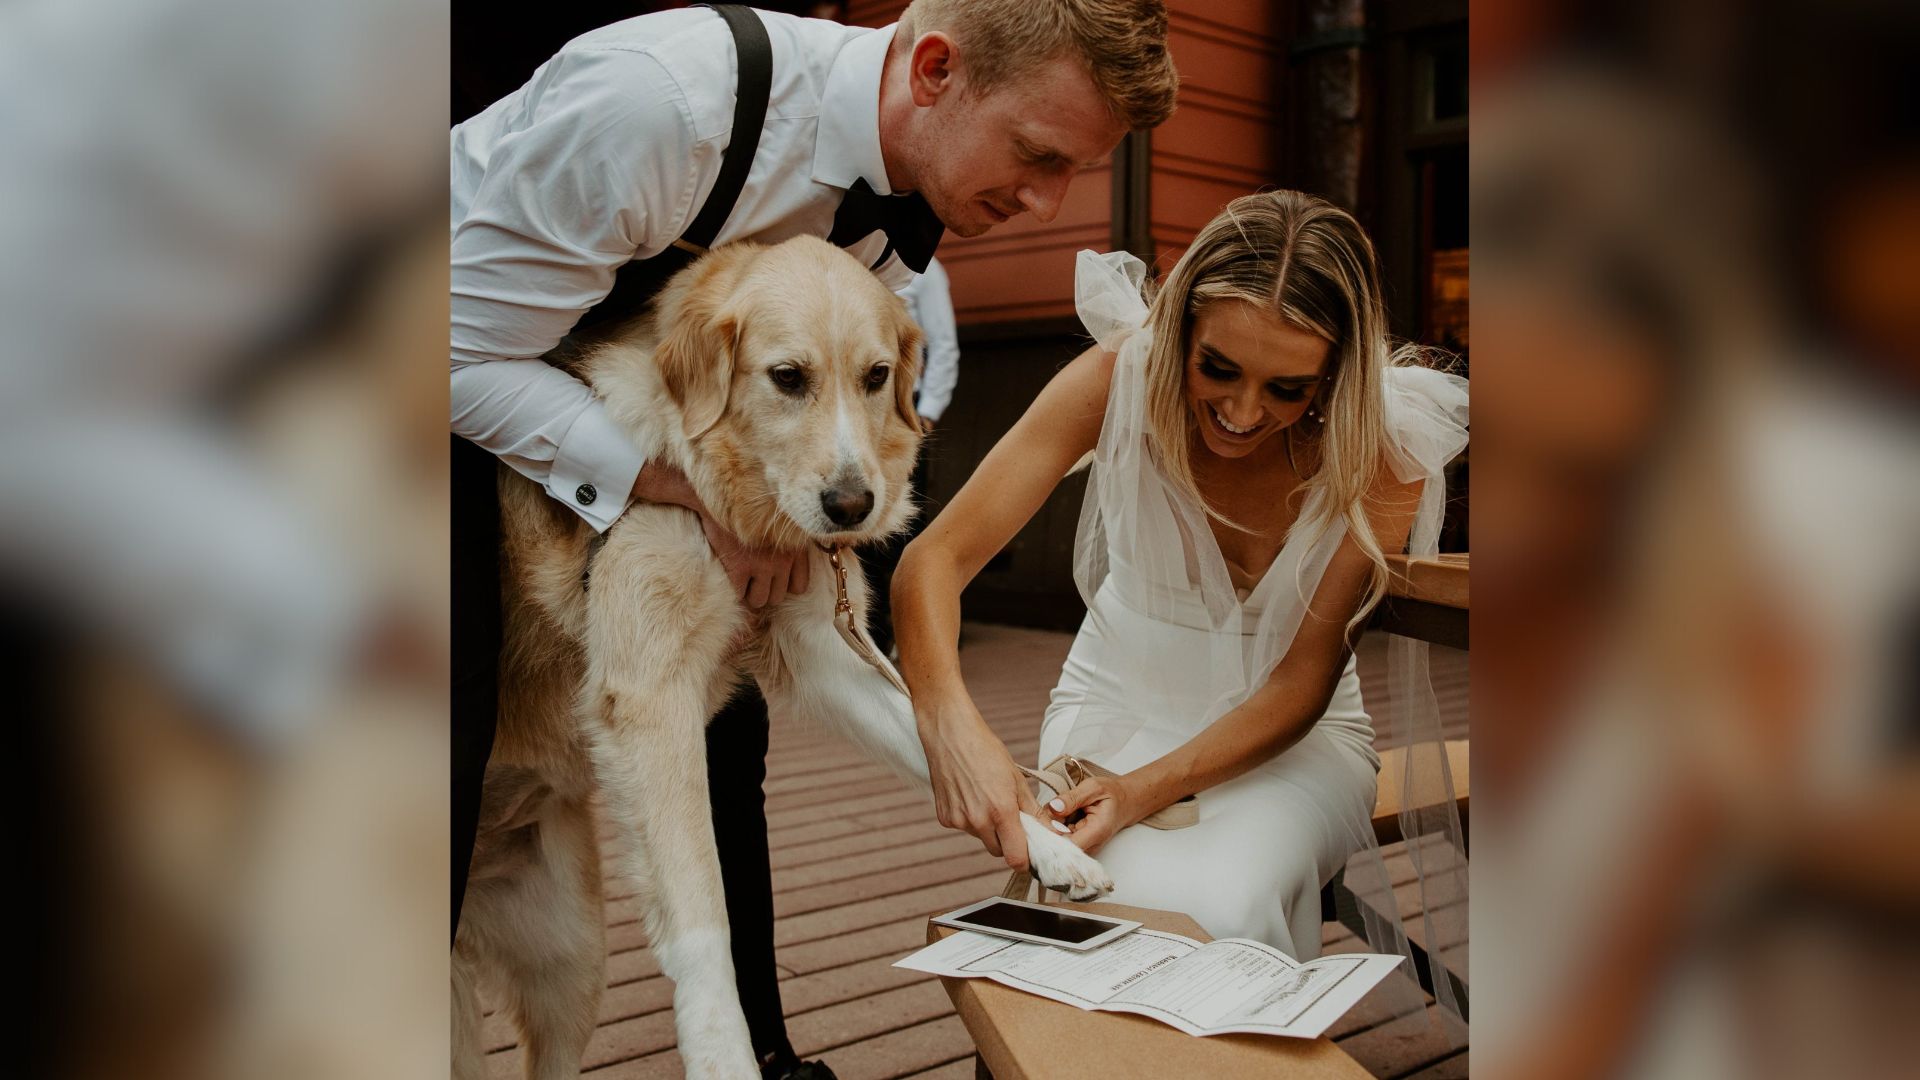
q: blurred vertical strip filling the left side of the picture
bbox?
[0,0,447,1080]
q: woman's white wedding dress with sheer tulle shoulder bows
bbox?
[1039,252,1467,959]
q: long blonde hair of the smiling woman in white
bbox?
[1144,190,1419,634]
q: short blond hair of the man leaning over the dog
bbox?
[897,0,1179,131]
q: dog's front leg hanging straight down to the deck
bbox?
[582,515,758,1080]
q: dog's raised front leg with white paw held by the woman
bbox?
[756,552,1114,899]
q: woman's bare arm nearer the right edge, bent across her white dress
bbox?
[1052,470,1421,851]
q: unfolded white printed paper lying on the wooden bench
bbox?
[893,928,1400,1038]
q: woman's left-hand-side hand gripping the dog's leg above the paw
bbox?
[920,701,1041,871]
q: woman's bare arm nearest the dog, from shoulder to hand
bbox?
[893,348,1114,869]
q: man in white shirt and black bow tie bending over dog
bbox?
[451,0,1175,1076]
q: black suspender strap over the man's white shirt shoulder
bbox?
[574,4,774,332]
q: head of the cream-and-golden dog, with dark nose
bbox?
[655,236,922,548]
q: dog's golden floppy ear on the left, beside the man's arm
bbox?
[653,248,749,438]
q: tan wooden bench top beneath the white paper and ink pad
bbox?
[927,903,1371,1080]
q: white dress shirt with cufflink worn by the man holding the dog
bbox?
[451,8,912,530]
